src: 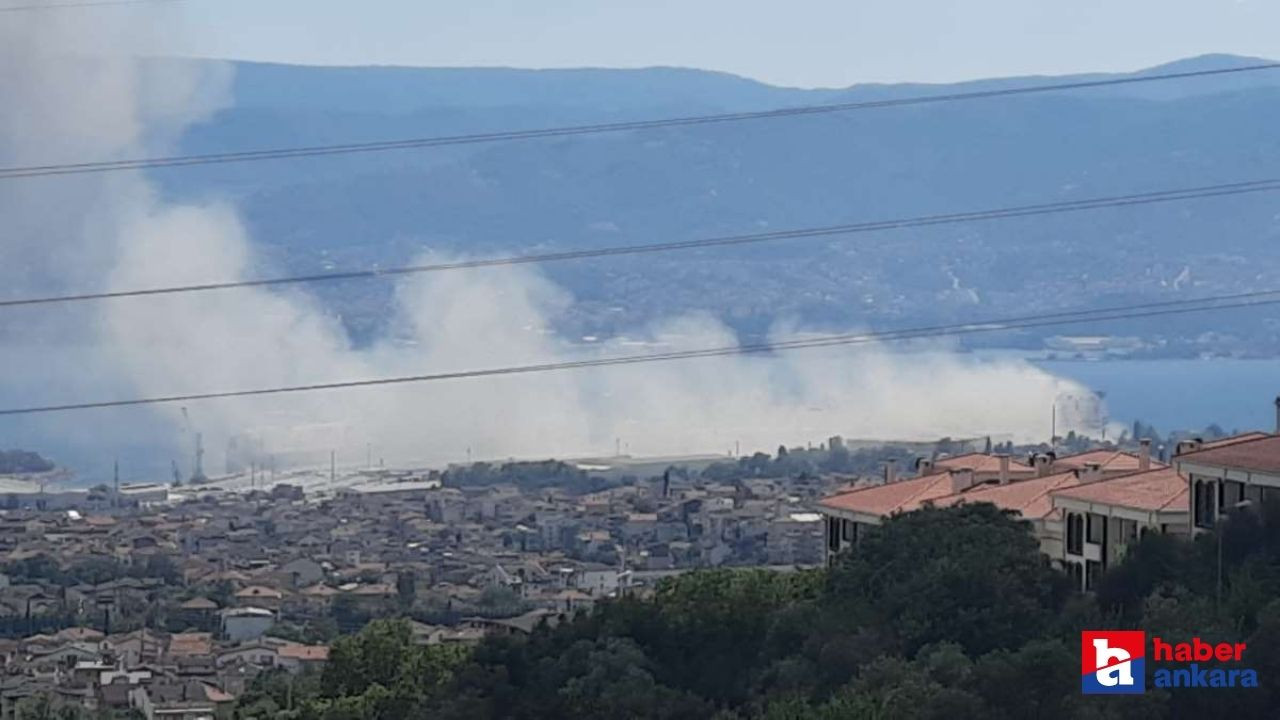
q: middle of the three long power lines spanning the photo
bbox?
[0,178,1280,309]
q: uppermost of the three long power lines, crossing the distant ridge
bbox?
[0,63,1280,179]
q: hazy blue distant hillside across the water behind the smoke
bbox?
[157,56,1280,350]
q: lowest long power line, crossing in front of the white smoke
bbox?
[0,290,1280,416]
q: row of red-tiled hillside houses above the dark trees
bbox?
[819,425,1280,589]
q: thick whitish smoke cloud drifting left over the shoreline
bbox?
[0,8,1091,479]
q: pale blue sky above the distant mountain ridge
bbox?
[55,0,1280,87]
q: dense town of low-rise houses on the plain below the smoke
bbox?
[0,450,838,720]
